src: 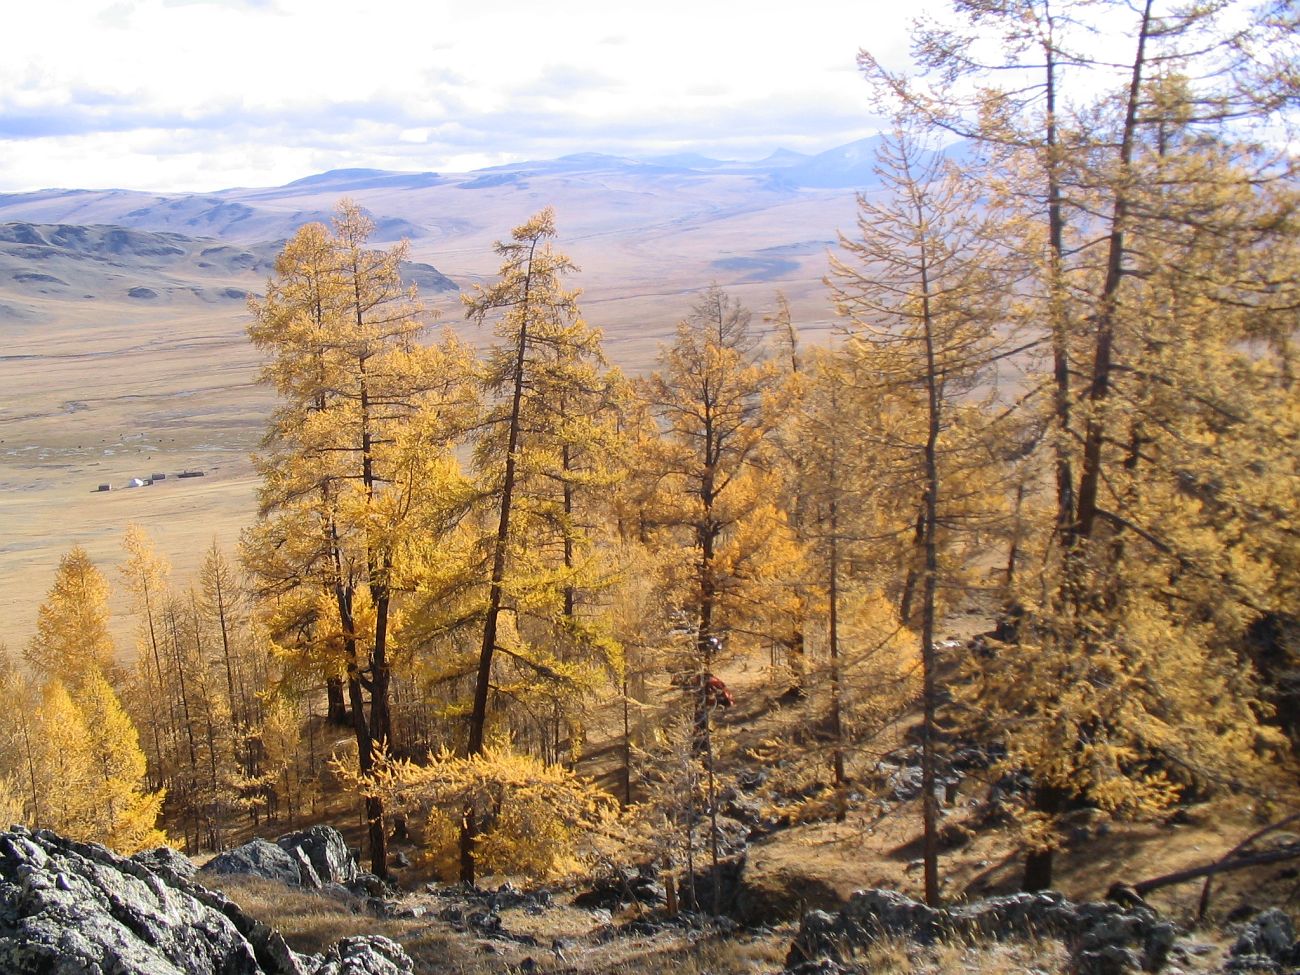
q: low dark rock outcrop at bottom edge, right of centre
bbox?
[787,889,1178,975]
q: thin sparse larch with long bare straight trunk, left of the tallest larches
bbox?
[831,121,1008,905]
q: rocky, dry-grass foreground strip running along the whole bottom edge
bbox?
[0,827,1300,975]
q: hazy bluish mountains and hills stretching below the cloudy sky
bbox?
[0,137,977,340]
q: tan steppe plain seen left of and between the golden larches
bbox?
[0,183,853,657]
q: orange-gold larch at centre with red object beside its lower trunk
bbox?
[638,286,797,909]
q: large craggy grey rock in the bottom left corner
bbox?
[0,827,411,975]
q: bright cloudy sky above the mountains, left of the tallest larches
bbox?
[0,0,935,191]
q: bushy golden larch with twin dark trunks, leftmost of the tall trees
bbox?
[244,202,467,876]
